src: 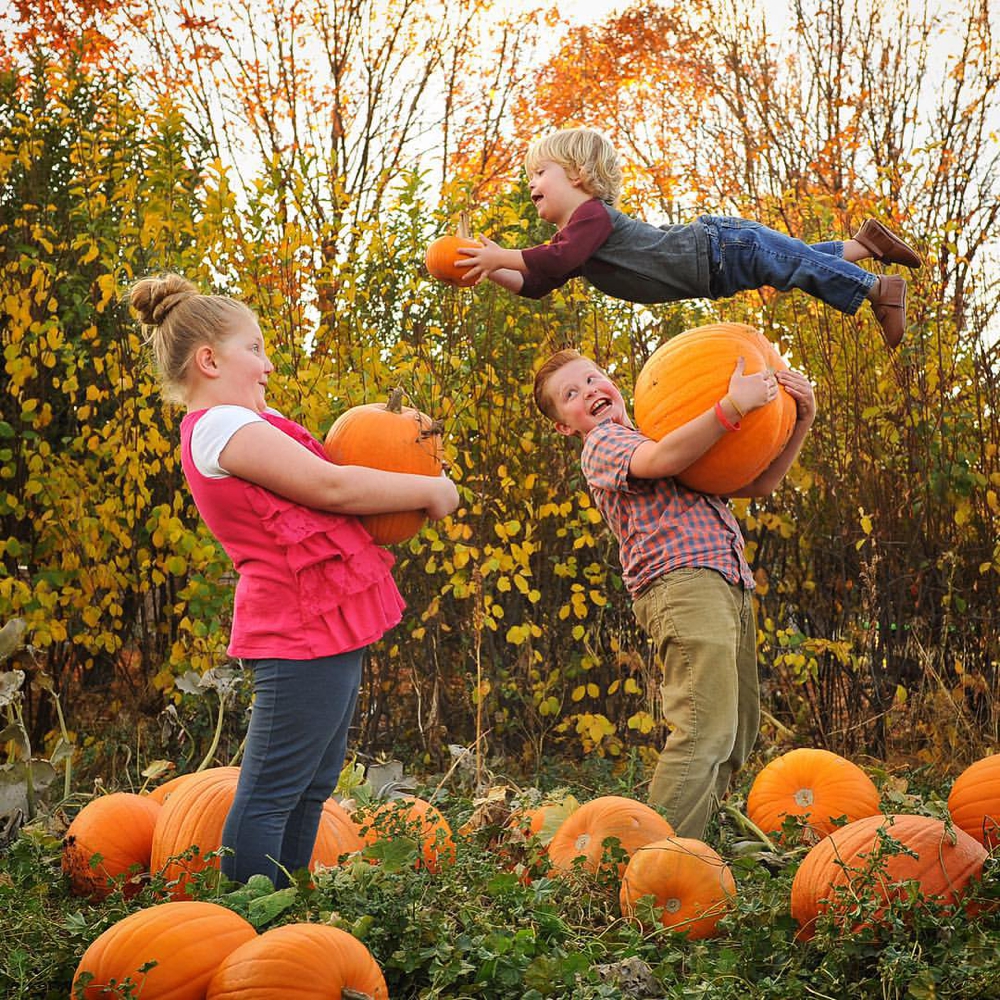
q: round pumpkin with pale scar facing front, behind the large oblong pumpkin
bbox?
[747,747,879,843]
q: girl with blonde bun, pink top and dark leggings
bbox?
[130,274,458,885]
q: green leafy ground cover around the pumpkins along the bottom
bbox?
[0,756,1000,1000]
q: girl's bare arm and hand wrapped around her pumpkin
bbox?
[219,420,458,520]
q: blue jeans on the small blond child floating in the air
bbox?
[699,215,877,316]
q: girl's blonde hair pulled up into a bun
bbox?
[129,273,255,405]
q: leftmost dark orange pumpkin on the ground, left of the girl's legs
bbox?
[62,792,160,901]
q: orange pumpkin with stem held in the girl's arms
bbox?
[323,389,444,545]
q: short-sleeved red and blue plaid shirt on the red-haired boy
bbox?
[580,420,754,596]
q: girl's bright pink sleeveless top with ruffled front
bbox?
[181,410,406,660]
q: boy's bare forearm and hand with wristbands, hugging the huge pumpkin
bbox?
[629,358,778,479]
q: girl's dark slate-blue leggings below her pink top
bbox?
[222,649,364,886]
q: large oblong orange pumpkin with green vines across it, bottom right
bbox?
[791,815,986,939]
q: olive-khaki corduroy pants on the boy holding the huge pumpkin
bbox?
[634,569,760,839]
